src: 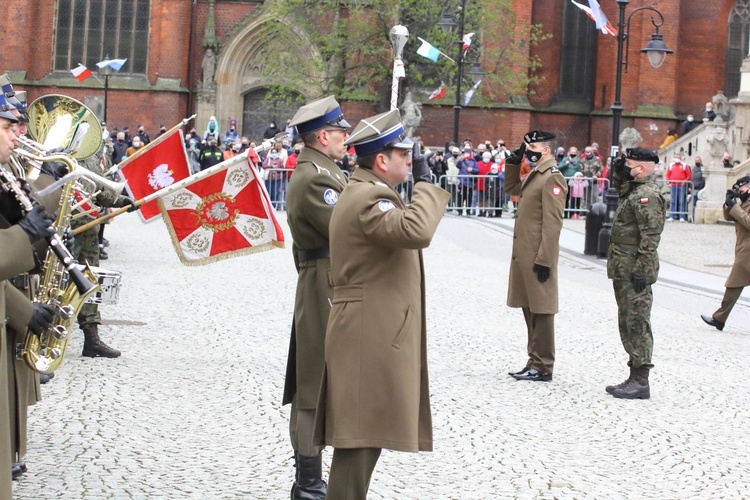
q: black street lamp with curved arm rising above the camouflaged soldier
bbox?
[610,0,674,156]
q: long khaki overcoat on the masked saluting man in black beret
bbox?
[505,158,568,314]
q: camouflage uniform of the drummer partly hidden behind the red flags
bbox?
[70,151,125,329]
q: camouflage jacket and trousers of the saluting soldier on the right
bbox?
[607,170,666,369]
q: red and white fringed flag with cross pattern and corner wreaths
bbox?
[159,156,284,266]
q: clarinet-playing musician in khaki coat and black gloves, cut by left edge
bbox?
[0,94,54,498]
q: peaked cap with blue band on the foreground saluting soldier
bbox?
[346,109,414,156]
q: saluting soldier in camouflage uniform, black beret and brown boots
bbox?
[606,148,666,399]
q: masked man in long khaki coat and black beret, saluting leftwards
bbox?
[505,130,568,381]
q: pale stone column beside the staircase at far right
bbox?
[695,121,732,224]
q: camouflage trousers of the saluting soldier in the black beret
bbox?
[612,280,654,369]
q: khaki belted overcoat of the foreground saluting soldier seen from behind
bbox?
[315,168,450,451]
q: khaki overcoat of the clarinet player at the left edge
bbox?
[0,226,34,498]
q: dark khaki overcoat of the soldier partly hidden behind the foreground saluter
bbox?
[282,146,346,410]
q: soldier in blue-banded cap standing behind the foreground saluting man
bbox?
[282,96,350,499]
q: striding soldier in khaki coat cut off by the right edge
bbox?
[701,176,750,330]
